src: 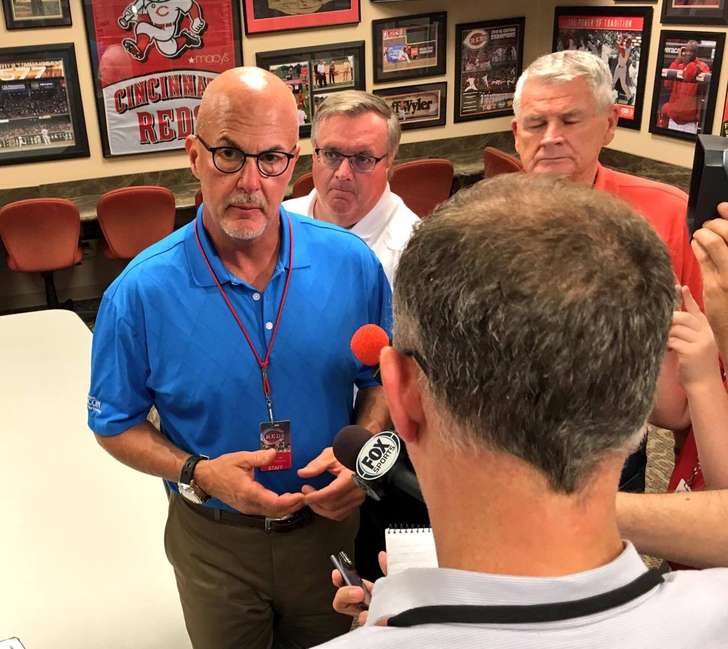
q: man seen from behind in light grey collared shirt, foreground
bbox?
[325,174,728,649]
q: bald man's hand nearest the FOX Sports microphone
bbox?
[296,446,364,521]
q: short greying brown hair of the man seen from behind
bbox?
[394,174,675,494]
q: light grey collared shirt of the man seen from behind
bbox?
[321,543,728,649]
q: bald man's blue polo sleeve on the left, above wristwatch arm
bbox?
[88,285,154,436]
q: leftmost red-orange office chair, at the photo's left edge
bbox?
[0,198,82,307]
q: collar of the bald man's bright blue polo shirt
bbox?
[184,205,311,287]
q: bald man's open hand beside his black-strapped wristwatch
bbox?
[195,449,304,518]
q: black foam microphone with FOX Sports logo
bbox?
[333,426,425,502]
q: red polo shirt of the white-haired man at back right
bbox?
[594,164,703,305]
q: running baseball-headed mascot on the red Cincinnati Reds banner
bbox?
[117,0,207,61]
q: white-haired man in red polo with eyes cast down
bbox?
[512,50,702,491]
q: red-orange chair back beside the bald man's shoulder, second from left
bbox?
[96,185,176,259]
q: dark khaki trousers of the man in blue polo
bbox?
[164,493,359,649]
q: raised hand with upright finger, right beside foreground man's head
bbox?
[667,286,720,391]
